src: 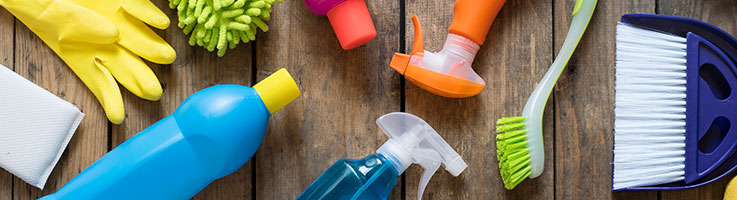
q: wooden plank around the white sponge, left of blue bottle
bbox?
[13,12,108,199]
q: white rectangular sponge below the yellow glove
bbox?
[0,65,84,189]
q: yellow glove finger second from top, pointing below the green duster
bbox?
[118,20,177,64]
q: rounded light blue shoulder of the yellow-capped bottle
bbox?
[171,85,271,177]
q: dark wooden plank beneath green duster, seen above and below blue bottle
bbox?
[112,1,253,199]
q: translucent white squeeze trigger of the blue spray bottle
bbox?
[412,149,442,200]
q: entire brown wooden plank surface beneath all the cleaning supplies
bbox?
[0,0,737,200]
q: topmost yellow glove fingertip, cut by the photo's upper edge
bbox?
[123,0,170,30]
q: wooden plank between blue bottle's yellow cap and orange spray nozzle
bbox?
[255,0,402,199]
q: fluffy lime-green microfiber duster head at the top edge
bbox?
[169,0,283,57]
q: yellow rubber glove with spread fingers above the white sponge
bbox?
[0,0,176,124]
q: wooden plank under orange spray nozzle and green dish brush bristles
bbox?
[404,0,554,199]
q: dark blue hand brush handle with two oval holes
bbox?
[685,33,737,184]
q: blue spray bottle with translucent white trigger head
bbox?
[297,112,467,200]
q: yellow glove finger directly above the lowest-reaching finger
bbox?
[103,45,163,101]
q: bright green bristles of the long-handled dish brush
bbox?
[496,117,532,190]
